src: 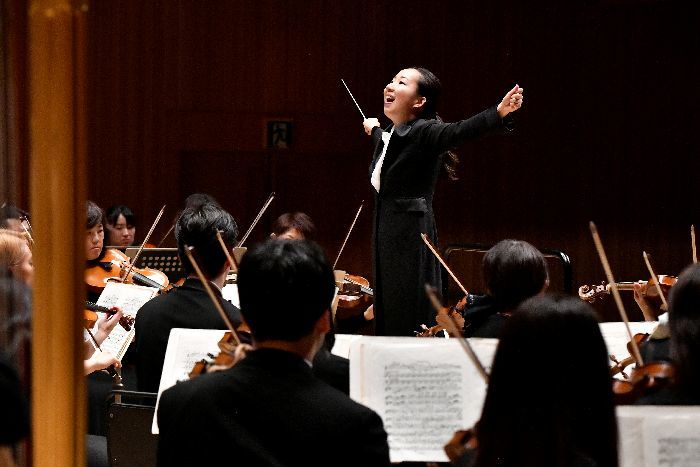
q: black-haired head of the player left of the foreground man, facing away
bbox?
[175,203,238,280]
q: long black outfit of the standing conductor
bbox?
[370,107,506,336]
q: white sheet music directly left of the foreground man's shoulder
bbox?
[151,328,226,435]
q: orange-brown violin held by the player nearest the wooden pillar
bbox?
[85,248,170,293]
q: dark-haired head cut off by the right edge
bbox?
[668,264,700,397]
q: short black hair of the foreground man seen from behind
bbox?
[238,240,335,341]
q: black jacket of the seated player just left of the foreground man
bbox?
[135,279,241,392]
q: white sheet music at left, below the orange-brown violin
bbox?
[95,282,158,361]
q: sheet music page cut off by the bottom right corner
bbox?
[617,405,700,467]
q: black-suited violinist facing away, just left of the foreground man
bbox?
[135,203,241,392]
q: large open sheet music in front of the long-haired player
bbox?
[350,336,498,462]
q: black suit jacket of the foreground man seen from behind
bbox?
[158,349,389,466]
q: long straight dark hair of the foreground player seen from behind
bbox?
[476,295,617,466]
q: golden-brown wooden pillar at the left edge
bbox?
[28,0,87,466]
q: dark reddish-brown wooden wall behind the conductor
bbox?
[89,0,700,317]
